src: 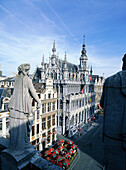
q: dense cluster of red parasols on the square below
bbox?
[40,139,78,170]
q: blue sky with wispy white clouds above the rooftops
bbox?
[0,0,126,77]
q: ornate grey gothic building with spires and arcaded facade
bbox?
[32,41,95,136]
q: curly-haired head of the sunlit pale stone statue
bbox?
[18,63,30,75]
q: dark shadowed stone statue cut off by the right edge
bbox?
[100,54,126,170]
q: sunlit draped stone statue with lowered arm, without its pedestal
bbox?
[8,64,41,154]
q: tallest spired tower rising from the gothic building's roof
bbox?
[80,36,88,70]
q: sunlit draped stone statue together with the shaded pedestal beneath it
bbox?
[1,64,41,170]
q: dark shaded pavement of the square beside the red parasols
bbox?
[58,115,104,170]
